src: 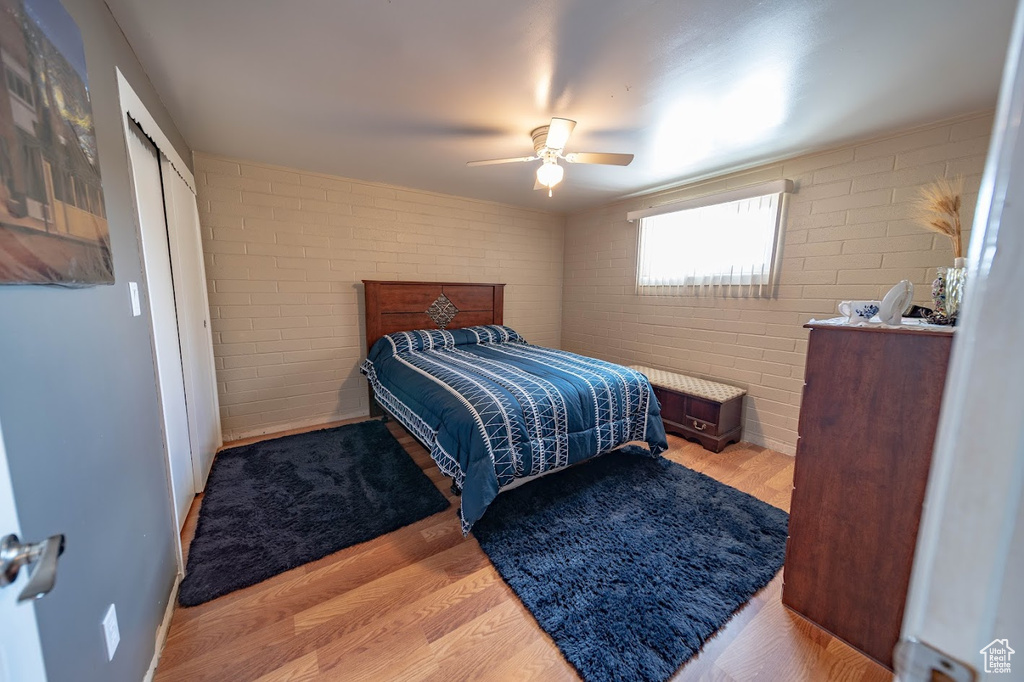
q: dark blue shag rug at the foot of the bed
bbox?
[473,446,788,682]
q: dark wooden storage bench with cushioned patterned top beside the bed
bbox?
[631,365,746,453]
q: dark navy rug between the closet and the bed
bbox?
[178,421,450,606]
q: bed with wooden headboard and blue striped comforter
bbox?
[360,281,668,532]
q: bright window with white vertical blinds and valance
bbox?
[627,180,793,296]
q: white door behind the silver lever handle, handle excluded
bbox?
[0,417,46,682]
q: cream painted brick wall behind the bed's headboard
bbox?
[196,155,564,440]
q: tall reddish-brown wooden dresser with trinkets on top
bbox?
[782,324,952,669]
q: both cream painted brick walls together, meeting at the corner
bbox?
[196,115,991,453]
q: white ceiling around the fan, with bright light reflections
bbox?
[108,0,1015,211]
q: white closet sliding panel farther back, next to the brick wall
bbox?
[161,155,222,493]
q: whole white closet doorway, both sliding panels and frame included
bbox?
[115,69,223,571]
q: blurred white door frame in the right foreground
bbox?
[896,0,1024,682]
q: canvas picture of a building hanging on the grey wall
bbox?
[0,0,114,287]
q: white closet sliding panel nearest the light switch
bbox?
[128,123,196,529]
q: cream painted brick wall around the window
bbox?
[562,114,992,454]
